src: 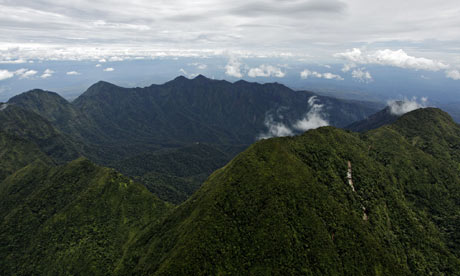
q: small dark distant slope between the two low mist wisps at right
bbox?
[345,106,400,132]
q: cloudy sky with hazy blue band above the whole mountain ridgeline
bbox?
[0,0,460,101]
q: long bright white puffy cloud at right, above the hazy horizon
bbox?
[334,48,449,72]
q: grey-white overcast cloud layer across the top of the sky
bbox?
[0,0,460,62]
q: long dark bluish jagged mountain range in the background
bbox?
[8,75,377,151]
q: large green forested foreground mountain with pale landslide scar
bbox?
[118,108,460,275]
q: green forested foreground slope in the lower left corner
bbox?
[0,158,170,275]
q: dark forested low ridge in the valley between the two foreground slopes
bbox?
[113,144,231,203]
